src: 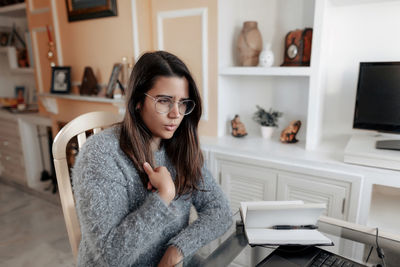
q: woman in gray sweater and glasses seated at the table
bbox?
[73,51,232,266]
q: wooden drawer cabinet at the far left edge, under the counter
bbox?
[0,117,27,185]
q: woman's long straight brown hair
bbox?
[120,51,204,196]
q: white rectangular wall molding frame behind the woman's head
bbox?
[155,7,208,121]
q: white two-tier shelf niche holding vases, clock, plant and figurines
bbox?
[218,0,322,149]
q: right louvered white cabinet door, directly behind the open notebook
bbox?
[277,173,349,219]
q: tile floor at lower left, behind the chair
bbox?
[0,182,74,267]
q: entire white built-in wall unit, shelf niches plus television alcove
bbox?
[216,0,400,245]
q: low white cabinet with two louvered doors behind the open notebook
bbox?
[209,151,361,222]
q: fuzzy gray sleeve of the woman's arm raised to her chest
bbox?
[72,134,176,266]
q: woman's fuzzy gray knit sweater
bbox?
[72,127,232,267]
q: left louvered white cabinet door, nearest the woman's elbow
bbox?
[219,161,277,213]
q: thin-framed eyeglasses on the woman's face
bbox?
[145,93,196,115]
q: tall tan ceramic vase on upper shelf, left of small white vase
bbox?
[237,21,262,66]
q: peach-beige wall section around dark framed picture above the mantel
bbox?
[55,0,134,91]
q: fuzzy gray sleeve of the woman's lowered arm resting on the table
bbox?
[169,167,232,257]
